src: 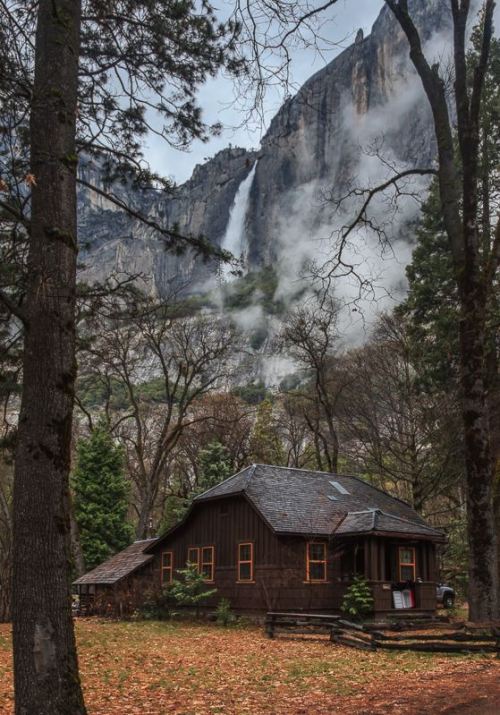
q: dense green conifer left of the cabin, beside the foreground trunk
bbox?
[72,423,133,569]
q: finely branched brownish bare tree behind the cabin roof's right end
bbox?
[339,315,463,512]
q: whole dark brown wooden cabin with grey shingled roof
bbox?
[75,464,445,614]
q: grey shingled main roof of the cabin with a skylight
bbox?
[190,464,443,540]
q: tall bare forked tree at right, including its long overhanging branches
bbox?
[243,0,500,621]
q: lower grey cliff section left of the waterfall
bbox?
[79,148,255,295]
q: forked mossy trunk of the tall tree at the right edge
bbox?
[385,0,500,621]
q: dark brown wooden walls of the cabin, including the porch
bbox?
[147,497,435,612]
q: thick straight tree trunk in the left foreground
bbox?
[13,0,86,715]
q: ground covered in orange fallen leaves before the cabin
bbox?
[0,618,500,715]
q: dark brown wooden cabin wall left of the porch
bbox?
[148,497,345,611]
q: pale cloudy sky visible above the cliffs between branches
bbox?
[145,0,500,183]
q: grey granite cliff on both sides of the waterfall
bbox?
[80,0,449,294]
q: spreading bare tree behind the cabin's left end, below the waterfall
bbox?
[82,305,237,538]
